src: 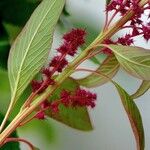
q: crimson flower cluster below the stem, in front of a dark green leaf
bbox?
[35,88,97,120]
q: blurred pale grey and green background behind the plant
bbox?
[0,0,150,150]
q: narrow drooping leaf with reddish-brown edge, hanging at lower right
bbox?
[113,82,145,150]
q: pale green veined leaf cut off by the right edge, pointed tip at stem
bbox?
[104,45,150,80]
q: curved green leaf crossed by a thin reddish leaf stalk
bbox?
[76,55,119,88]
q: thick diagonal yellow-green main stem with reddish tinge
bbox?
[0,0,148,145]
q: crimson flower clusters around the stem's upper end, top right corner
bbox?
[103,0,150,55]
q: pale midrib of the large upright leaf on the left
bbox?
[13,0,57,97]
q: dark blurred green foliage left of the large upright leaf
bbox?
[0,0,40,69]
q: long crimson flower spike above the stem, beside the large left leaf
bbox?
[31,29,86,93]
